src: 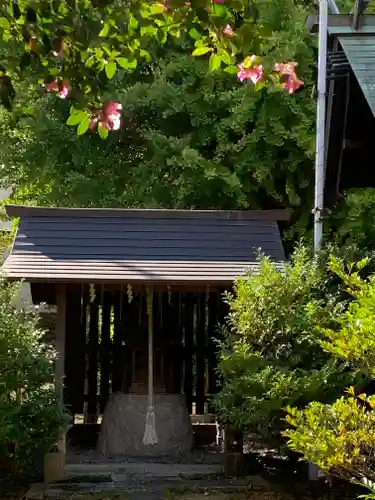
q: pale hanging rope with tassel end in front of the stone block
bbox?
[142,287,159,445]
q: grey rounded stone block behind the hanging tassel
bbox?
[98,393,193,456]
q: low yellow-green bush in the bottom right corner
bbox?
[284,390,375,481]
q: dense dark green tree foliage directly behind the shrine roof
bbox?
[0,33,315,235]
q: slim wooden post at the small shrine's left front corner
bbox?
[55,283,66,453]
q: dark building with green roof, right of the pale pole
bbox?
[308,14,375,207]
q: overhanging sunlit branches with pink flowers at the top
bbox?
[0,0,310,138]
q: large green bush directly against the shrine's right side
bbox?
[216,248,353,437]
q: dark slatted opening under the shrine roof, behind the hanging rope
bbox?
[64,284,227,423]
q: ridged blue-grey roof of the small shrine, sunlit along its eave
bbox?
[3,205,289,284]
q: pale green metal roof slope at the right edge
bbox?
[339,35,375,116]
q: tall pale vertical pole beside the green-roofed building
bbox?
[314,0,328,250]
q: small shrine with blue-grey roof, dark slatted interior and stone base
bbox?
[3,205,288,455]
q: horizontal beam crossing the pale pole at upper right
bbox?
[307,14,375,36]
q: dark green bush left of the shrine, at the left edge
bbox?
[0,281,67,470]
